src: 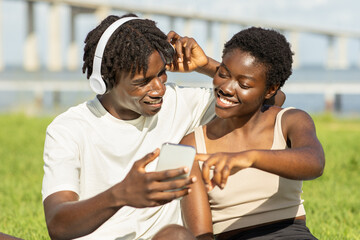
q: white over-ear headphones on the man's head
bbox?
[89,17,139,94]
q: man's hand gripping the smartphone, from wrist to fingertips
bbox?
[112,149,196,208]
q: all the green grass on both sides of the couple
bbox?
[0,115,360,240]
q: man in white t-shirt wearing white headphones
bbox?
[42,15,217,239]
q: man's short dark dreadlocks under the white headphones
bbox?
[82,14,172,89]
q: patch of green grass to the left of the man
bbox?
[0,115,51,240]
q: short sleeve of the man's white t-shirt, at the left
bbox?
[42,124,80,201]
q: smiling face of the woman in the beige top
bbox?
[213,49,267,118]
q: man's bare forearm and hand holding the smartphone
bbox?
[44,149,194,239]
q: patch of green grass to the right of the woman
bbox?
[302,116,360,240]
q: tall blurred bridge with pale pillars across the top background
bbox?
[0,0,360,71]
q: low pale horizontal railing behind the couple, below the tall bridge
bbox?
[0,79,360,113]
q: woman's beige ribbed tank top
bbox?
[195,108,305,234]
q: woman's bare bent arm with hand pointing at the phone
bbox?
[197,109,325,189]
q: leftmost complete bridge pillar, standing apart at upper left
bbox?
[23,1,39,71]
